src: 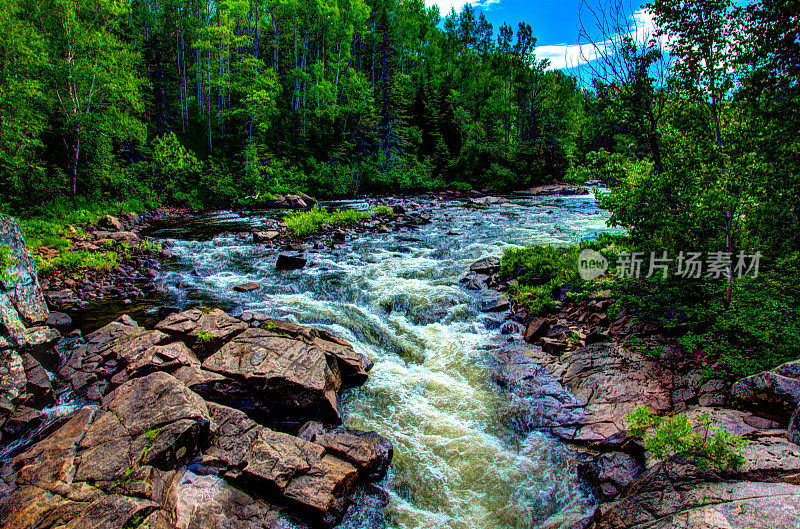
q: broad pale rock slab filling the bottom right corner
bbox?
[589,457,800,529]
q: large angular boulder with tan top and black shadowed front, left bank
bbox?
[198,327,342,424]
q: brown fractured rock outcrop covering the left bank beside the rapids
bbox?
[0,212,393,528]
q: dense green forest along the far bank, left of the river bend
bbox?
[0,0,584,207]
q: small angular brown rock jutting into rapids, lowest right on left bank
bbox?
[298,422,394,481]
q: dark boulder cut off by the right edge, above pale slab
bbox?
[731,360,800,424]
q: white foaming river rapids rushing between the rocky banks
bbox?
[141,196,606,529]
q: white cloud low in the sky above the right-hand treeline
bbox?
[536,9,665,70]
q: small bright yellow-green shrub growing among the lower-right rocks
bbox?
[625,406,745,470]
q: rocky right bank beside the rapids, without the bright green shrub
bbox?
[465,260,800,529]
